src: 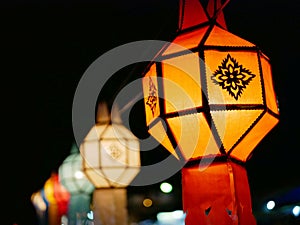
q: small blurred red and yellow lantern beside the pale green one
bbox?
[43,172,70,225]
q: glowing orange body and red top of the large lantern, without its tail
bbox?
[143,0,279,162]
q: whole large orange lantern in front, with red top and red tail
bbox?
[143,0,279,225]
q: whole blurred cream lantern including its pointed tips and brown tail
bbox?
[80,102,140,225]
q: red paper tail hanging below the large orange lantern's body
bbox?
[182,161,256,225]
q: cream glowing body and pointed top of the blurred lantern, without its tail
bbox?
[80,102,140,188]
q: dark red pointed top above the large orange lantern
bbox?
[178,0,230,32]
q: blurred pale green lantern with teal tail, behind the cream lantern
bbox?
[58,143,95,225]
